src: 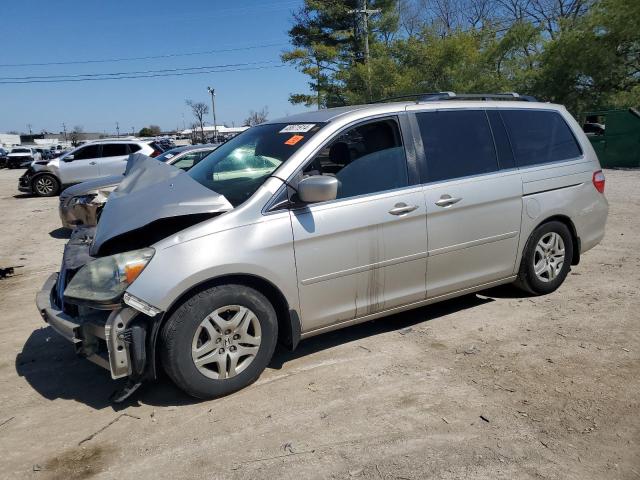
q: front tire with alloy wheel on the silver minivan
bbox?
[161,285,278,399]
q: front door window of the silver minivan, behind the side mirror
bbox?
[303,119,409,198]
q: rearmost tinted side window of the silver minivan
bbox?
[500,110,582,168]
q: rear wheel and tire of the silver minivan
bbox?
[515,221,573,295]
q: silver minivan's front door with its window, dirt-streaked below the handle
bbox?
[291,117,427,331]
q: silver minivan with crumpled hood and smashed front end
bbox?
[37,93,608,399]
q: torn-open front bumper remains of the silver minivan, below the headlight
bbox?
[36,273,146,379]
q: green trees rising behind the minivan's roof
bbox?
[282,0,640,115]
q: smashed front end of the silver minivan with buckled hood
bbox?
[36,159,233,392]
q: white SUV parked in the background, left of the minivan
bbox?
[18,140,162,197]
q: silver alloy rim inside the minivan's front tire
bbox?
[191,305,261,380]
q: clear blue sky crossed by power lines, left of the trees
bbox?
[0,0,308,133]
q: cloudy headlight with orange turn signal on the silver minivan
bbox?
[64,248,155,308]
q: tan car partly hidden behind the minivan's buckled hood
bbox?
[59,145,217,229]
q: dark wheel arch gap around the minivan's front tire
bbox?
[147,274,301,378]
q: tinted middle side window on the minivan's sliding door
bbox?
[416,110,498,182]
